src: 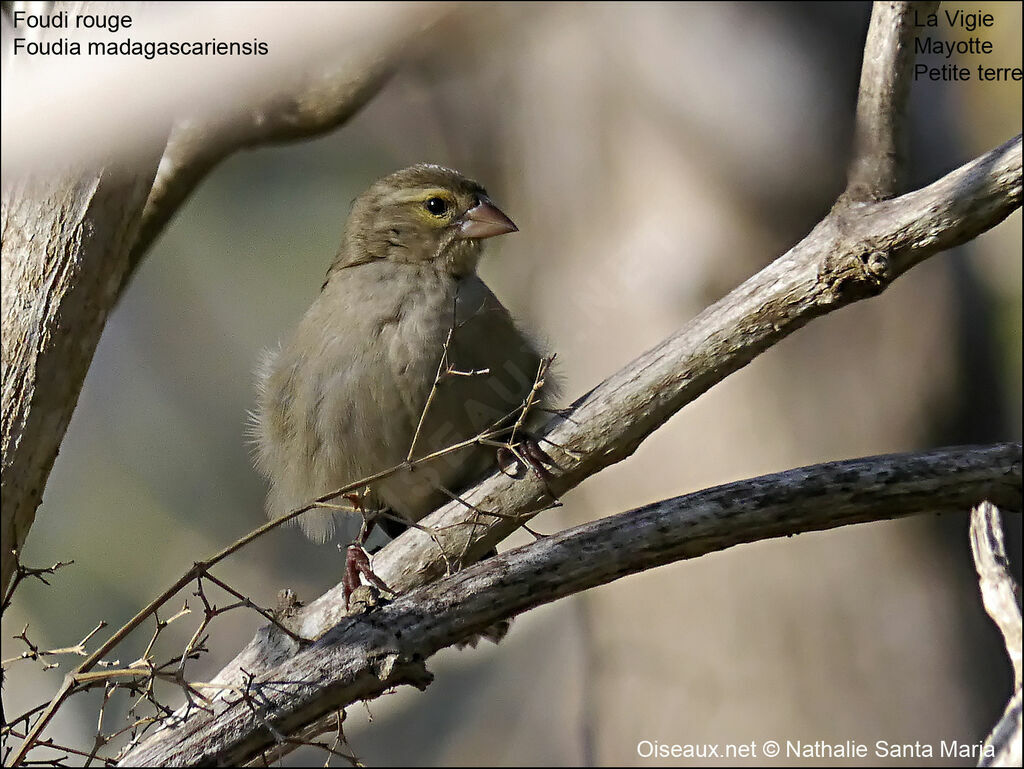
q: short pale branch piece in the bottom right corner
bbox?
[971,502,1022,766]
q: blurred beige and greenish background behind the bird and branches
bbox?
[3,2,1021,766]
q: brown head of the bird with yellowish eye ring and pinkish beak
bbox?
[332,164,518,276]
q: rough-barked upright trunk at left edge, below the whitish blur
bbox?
[0,153,159,586]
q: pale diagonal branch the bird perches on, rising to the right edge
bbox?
[153,136,1021,741]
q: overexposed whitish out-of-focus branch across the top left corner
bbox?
[2,0,460,177]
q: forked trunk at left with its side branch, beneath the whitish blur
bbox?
[0,3,448,587]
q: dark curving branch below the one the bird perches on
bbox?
[122,443,1022,766]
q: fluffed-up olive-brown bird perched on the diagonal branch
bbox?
[251,164,556,587]
